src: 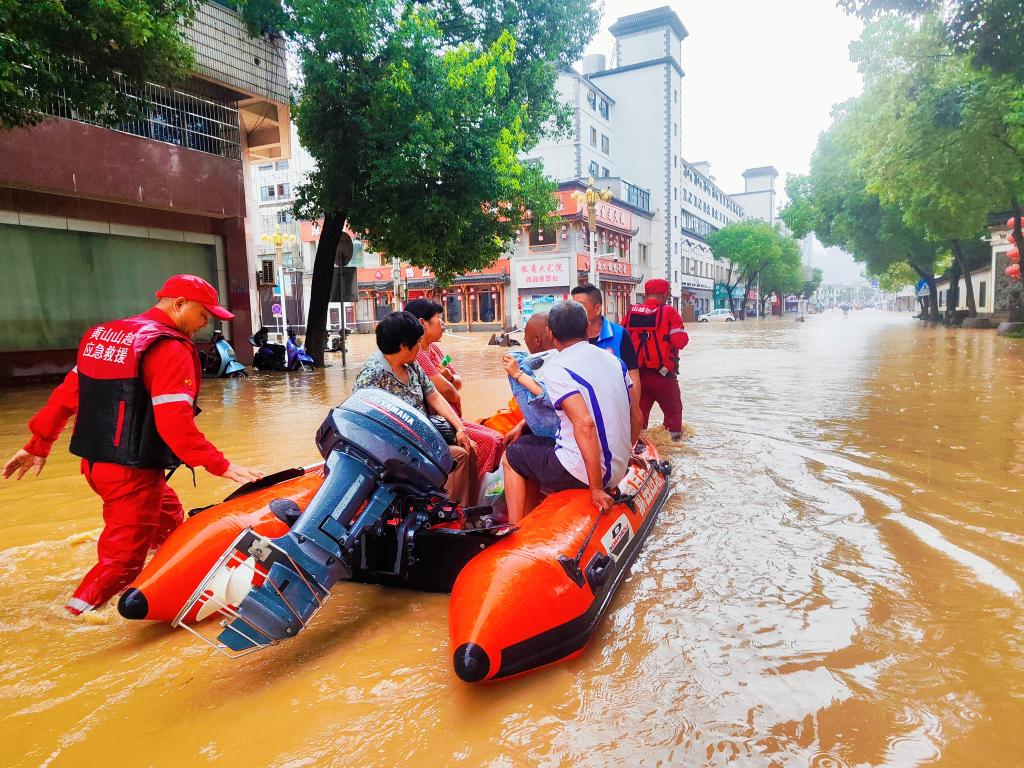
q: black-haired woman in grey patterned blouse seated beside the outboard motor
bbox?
[353,312,479,505]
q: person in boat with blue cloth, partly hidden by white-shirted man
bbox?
[502,312,558,437]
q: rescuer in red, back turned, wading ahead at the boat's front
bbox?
[624,279,690,441]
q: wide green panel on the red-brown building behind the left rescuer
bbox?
[0,224,217,351]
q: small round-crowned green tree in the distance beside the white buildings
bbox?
[708,219,803,319]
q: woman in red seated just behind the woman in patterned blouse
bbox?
[406,299,504,478]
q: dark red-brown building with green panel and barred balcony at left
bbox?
[0,2,290,383]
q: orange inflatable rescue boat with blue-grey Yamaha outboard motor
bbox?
[118,390,670,682]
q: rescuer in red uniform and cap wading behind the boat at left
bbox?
[3,274,262,615]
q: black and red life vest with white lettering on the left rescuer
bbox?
[70,314,203,469]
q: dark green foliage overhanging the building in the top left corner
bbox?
[0,0,200,128]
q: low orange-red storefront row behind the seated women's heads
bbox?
[356,259,509,333]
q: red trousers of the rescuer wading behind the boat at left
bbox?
[68,459,184,613]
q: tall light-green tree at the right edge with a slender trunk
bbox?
[854,16,1024,317]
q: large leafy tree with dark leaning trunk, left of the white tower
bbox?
[248,0,597,362]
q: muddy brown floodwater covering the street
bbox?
[0,312,1024,768]
